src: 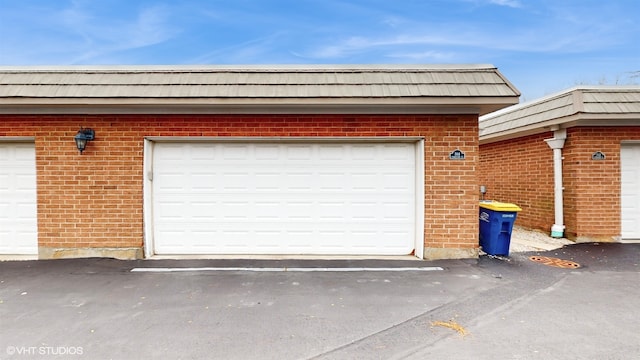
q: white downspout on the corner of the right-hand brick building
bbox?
[544,126,567,238]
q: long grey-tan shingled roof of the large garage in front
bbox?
[0,65,520,114]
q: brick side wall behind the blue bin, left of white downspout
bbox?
[479,132,554,231]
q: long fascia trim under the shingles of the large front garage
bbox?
[0,96,517,115]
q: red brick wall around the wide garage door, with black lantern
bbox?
[0,115,478,256]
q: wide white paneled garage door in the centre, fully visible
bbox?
[152,142,416,255]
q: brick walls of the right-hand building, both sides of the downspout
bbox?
[480,127,640,240]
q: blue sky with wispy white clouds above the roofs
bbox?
[0,0,640,101]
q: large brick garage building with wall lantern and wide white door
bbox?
[0,66,519,259]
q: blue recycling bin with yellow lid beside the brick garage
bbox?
[480,200,522,256]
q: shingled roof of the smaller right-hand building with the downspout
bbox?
[480,86,640,143]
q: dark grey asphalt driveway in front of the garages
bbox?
[0,244,640,359]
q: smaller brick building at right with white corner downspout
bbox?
[480,86,640,241]
